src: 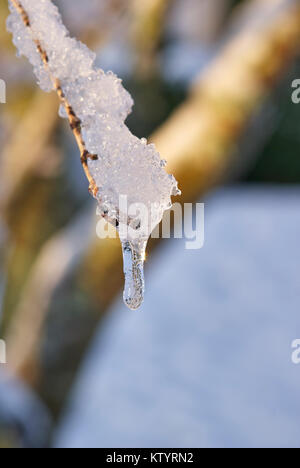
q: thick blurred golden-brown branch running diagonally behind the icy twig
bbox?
[80,0,300,306]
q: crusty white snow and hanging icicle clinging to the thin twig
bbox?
[7,0,179,309]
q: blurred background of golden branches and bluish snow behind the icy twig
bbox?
[0,0,300,448]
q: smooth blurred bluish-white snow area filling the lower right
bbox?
[55,187,300,448]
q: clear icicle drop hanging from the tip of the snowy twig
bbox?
[122,240,147,310]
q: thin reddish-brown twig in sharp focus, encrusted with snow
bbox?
[11,0,98,198]
